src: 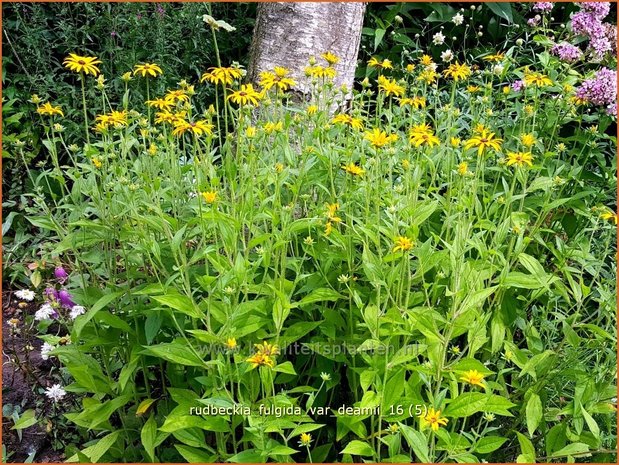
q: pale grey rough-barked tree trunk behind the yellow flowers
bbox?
[248,2,365,94]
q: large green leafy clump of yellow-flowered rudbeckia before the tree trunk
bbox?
[3,4,617,462]
